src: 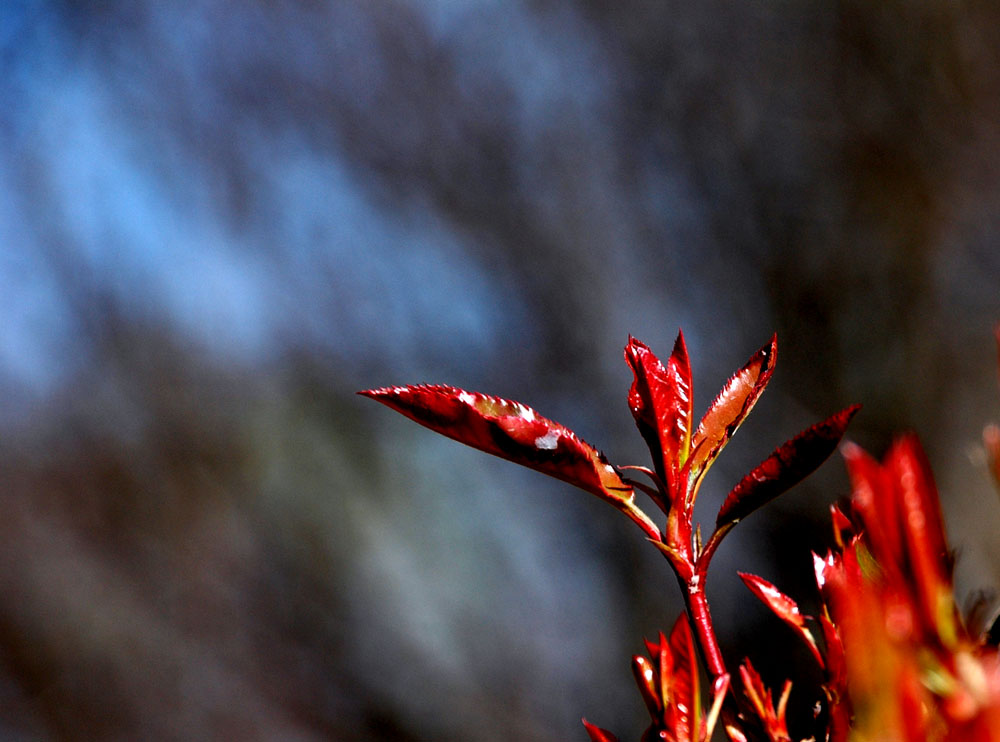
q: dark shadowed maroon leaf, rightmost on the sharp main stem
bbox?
[715,405,859,528]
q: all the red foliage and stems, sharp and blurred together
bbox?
[361,334,1000,742]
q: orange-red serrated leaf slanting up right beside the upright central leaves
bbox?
[690,335,778,475]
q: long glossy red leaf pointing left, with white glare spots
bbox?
[358,385,660,540]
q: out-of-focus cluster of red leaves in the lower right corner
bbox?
[814,436,1000,742]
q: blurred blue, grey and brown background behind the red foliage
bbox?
[0,0,1000,742]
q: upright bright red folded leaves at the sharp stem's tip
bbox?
[625,332,692,493]
